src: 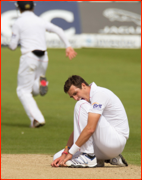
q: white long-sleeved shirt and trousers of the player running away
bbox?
[9,11,70,124]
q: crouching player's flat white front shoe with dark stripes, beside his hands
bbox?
[66,153,97,168]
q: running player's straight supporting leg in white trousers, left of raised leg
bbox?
[17,53,45,125]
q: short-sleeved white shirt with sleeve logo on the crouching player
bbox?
[89,82,129,139]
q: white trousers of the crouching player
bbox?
[53,100,126,160]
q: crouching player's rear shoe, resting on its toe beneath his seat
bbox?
[110,154,128,167]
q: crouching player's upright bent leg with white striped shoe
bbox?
[66,100,97,167]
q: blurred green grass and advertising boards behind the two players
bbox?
[1,1,141,165]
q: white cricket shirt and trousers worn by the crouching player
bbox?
[54,82,129,160]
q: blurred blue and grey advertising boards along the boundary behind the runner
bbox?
[1,1,141,48]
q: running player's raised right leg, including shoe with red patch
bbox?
[32,52,48,96]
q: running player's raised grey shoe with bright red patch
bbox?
[39,76,48,96]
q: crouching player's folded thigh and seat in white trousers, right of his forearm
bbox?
[93,116,126,159]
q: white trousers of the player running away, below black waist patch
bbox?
[17,52,48,124]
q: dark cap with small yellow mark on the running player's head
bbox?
[17,1,34,11]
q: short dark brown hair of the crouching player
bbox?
[64,75,89,93]
